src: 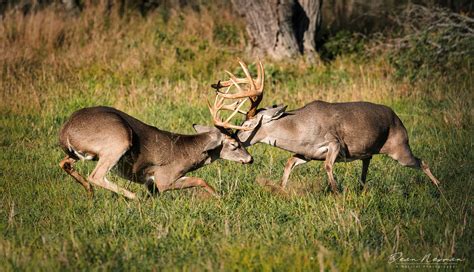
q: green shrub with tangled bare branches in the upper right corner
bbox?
[390,5,474,81]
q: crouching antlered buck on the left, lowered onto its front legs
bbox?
[59,90,253,199]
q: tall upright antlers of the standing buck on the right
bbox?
[212,60,265,119]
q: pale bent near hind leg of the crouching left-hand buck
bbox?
[88,157,135,199]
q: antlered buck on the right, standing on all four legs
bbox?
[211,60,440,194]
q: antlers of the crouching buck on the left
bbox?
[207,83,250,130]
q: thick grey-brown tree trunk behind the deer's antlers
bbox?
[232,0,322,59]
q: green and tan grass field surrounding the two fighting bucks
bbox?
[0,3,474,271]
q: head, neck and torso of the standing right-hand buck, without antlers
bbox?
[238,101,406,157]
